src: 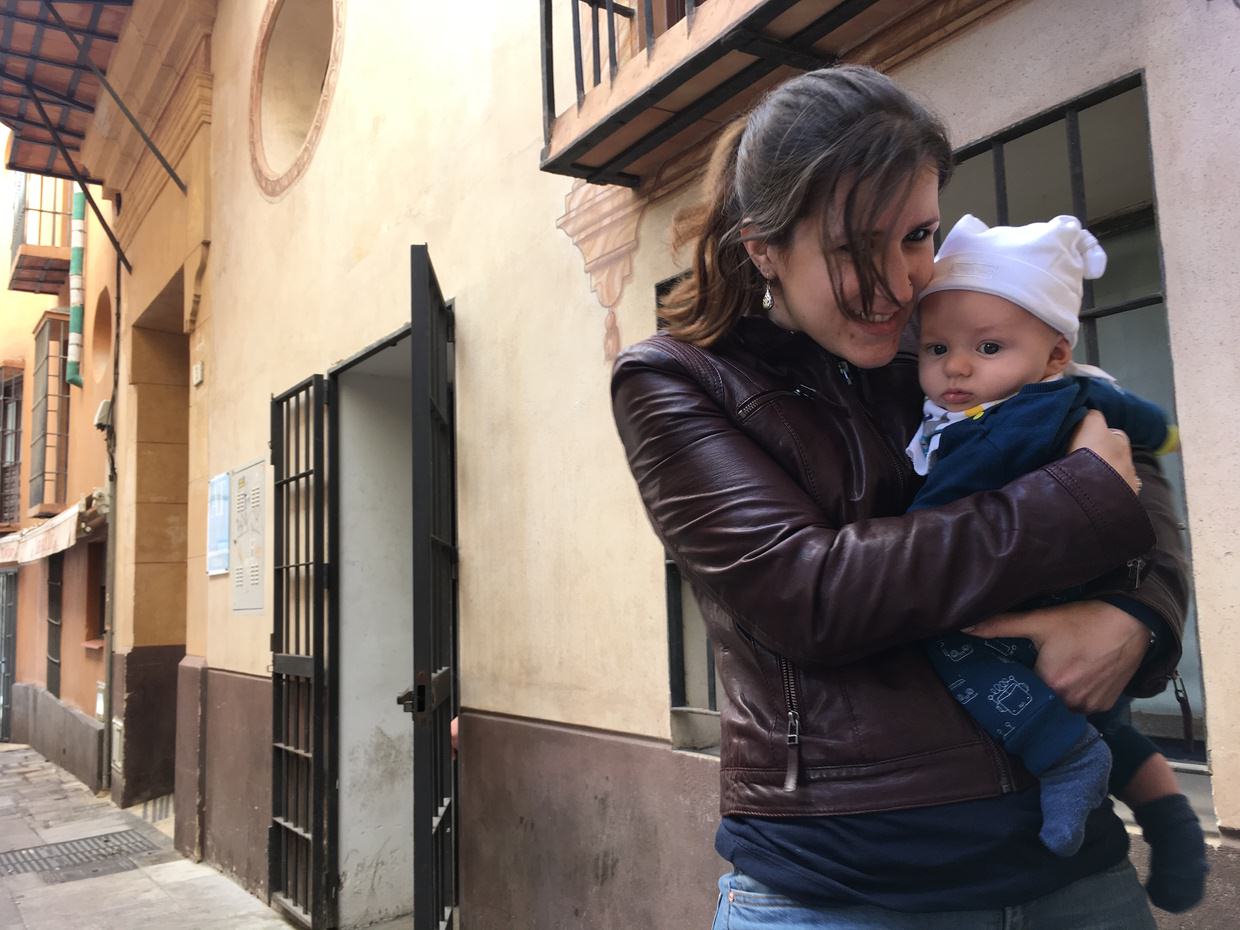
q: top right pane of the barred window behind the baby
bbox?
[1079,88,1154,222]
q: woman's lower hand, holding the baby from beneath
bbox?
[965,600,1149,714]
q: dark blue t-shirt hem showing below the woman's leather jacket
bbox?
[714,786,1128,913]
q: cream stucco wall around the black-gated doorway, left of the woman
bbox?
[195,0,667,735]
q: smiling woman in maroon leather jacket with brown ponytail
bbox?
[613,67,1184,930]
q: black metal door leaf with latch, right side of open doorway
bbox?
[399,246,459,930]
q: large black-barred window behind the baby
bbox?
[941,76,1205,761]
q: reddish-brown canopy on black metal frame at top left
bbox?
[0,0,133,180]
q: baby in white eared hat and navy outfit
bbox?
[908,216,1207,911]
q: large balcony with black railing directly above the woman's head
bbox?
[541,0,1008,187]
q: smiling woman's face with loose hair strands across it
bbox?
[746,167,939,368]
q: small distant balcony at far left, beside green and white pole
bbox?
[9,175,69,294]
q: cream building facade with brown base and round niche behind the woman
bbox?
[2,0,1240,930]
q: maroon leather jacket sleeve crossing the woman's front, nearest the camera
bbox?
[611,342,1153,665]
